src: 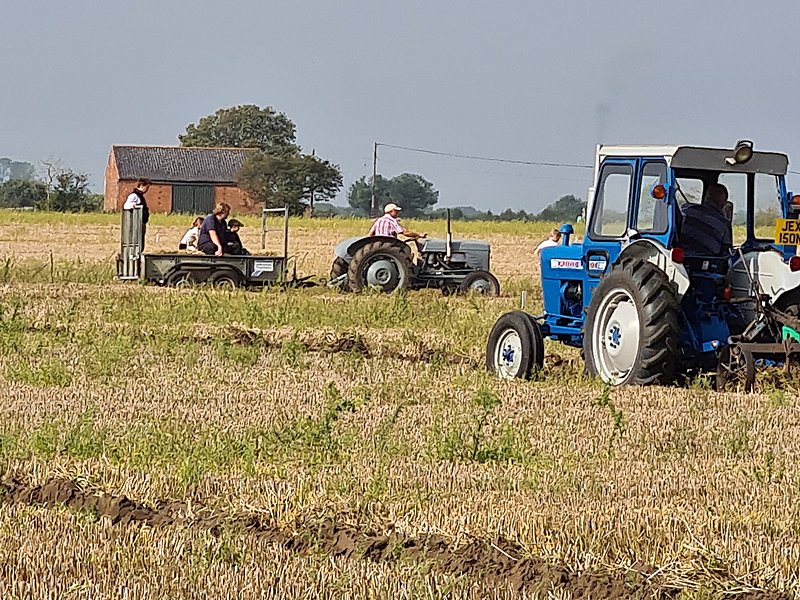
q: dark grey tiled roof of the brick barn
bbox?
[111,146,253,183]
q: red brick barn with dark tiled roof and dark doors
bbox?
[103,145,261,215]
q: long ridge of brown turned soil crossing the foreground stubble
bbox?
[0,479,791,600]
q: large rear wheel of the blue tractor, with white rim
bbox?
[583,259,680,385]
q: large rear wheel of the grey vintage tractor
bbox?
[347,241,411,292]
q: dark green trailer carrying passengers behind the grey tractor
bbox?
[117,207,311,288]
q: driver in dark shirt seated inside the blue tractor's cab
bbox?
[680,183,733,257]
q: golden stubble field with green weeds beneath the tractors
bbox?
[0,212,800,599]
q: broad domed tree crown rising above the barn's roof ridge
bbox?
[178,104,299,152]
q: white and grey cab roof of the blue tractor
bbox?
[596,145,789,175]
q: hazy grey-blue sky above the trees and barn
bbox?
[0,0,800,211]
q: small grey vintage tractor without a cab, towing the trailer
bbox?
[328,211,500,296]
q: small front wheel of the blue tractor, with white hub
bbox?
[486,310,544,379]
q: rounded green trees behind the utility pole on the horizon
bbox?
[347,173,439,217]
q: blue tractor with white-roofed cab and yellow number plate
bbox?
[486,140,800,390]
